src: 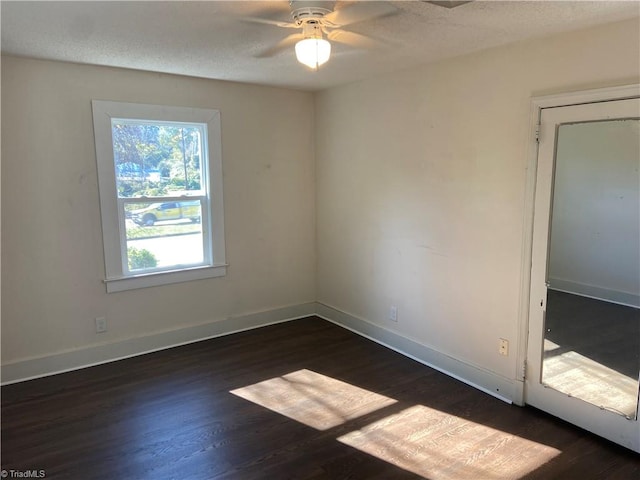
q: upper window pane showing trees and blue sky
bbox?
[111,123,204,198]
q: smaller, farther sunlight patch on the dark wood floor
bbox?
[231,369,396,430]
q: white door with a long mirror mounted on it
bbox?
[525,94,640,452]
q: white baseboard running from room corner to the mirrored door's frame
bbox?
[316,303,524,405]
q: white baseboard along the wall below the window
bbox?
[1,303,316,385]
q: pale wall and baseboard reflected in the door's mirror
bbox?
[548,120,640,307]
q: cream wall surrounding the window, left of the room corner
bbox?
[2,57,315,365]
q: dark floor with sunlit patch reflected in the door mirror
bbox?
[542,290,640,419]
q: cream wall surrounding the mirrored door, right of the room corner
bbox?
[316,19,640,388]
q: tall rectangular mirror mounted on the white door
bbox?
[542,119,640,419]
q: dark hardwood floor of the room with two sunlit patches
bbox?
[1,317,640,480]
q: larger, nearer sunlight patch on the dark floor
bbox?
[338,405,560,480]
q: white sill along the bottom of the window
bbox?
[104,264,228,293]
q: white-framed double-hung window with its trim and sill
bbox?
[92,100,226,292]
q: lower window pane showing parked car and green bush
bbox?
[124,200,204,273]
